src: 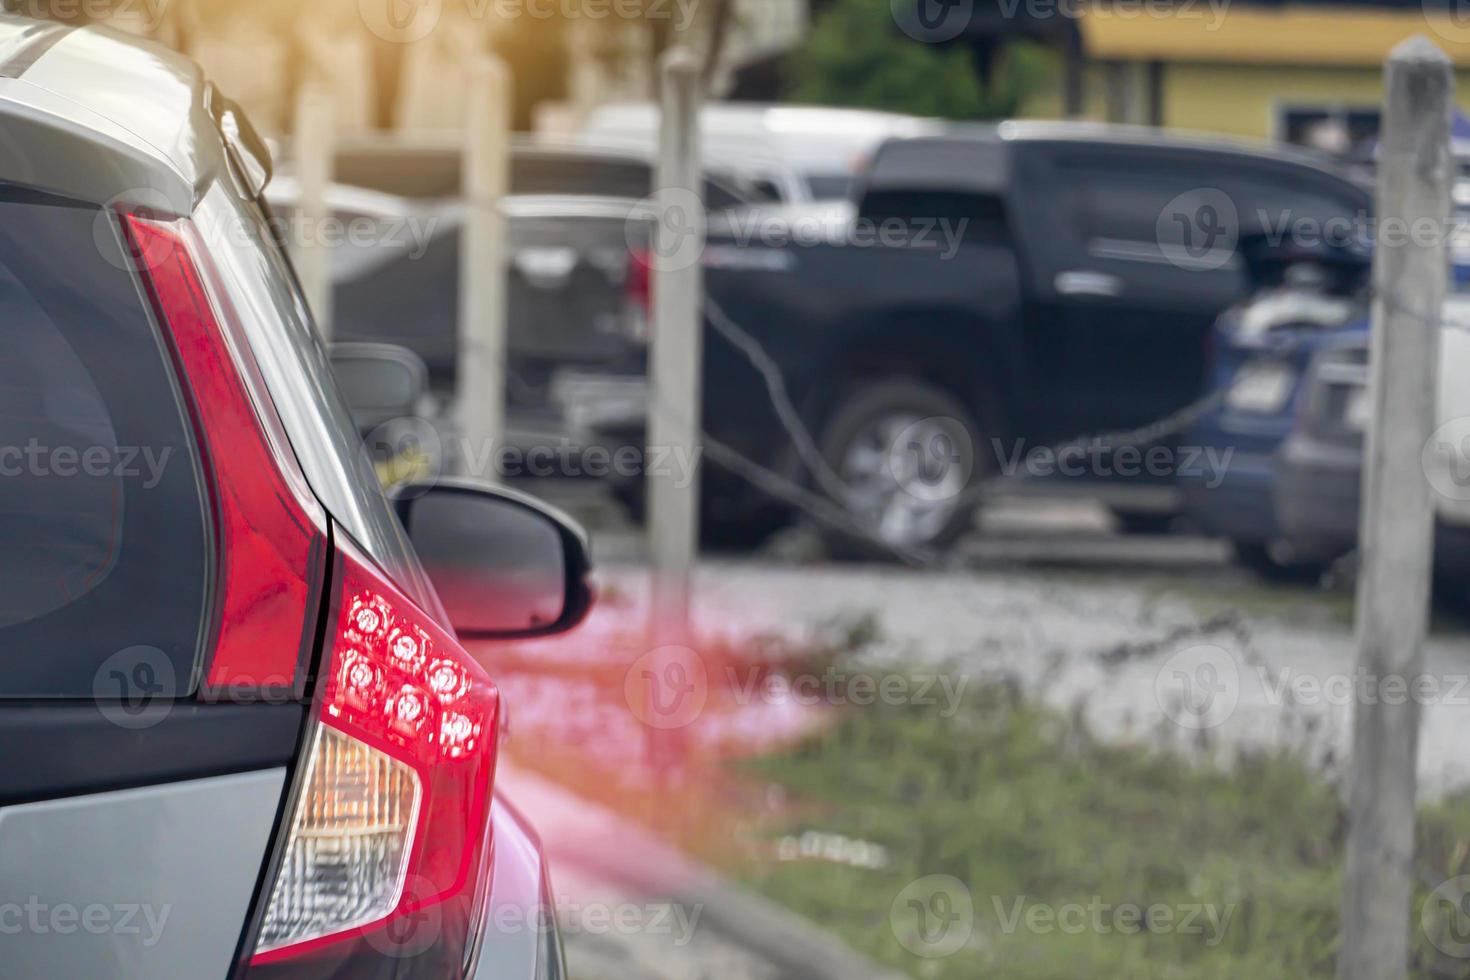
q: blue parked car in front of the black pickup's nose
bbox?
[1179,242,1370,579]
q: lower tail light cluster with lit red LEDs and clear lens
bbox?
[251,541,500,976]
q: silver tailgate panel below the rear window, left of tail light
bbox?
[0,768,285,980]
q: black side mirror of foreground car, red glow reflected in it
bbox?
[392,479,592,639]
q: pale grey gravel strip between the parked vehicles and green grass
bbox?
[632,563,1470,798]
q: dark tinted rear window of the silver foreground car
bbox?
[0,185,209,698]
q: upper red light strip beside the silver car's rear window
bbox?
[122,215,326,696]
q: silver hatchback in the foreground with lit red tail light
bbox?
[0,15,589,980]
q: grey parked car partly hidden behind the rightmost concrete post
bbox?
[1272,266,1470,598]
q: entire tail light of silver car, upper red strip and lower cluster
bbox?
[121,213,500,980]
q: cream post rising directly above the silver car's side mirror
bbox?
[457,54,512,480]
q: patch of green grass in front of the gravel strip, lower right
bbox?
[728,675,1470,980]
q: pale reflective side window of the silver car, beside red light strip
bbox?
[196,184,444,620]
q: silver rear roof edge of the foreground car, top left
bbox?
[0,13,214,213]
